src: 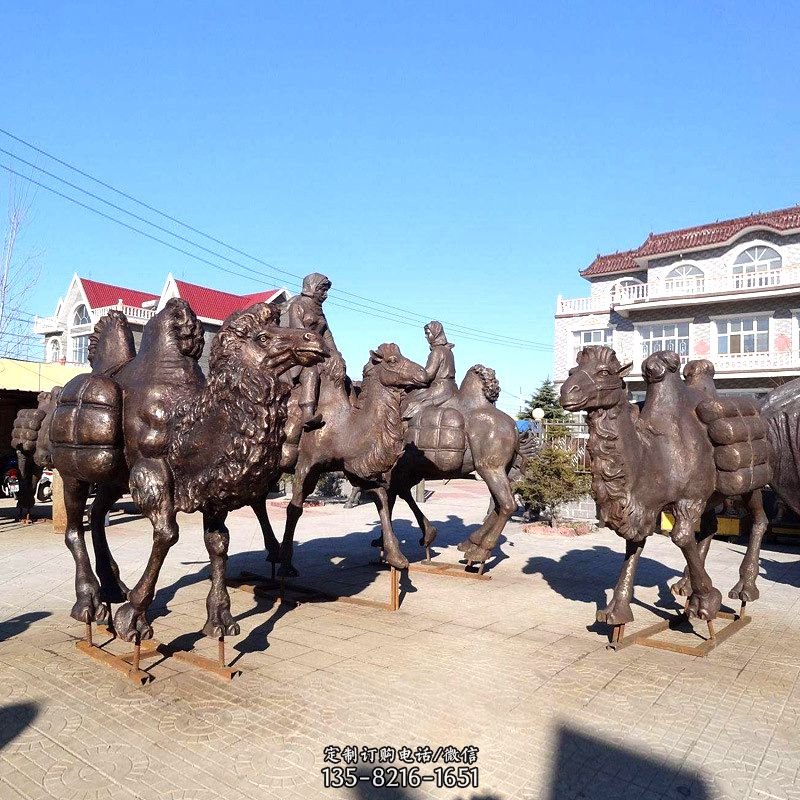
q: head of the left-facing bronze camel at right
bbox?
[561,345,633,411]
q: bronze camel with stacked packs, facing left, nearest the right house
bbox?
[561,346,771,625]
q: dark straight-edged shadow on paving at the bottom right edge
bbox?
[542,724,711,800]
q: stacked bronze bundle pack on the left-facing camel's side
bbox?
[697,397,772,495]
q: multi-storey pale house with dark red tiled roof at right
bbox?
[554,206,800,398]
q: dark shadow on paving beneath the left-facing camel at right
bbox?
[522,544,683,630]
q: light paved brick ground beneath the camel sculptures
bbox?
[0,482,800,800]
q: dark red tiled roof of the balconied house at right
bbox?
[581,206,800,277]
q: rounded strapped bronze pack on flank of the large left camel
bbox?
[50,373,124,483]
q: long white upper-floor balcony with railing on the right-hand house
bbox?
[556,264,800,314]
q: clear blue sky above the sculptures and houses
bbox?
[0,1,800,410]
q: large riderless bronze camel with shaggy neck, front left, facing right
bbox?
[49,299,327,641]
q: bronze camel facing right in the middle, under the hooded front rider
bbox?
[253,344,425,577]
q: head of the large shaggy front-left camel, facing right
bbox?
[209,303,330,377]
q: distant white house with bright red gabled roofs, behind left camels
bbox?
[34,274,289,369]
